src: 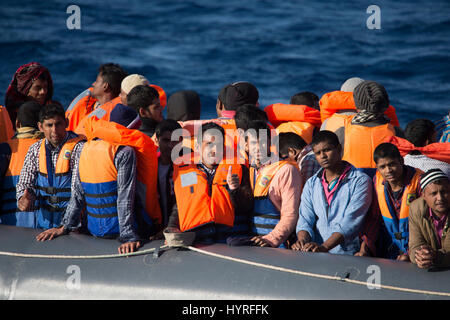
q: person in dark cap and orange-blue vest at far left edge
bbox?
[0,101,44,227]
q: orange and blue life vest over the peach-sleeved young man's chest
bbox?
[250,160,296,247]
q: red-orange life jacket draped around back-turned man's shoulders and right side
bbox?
[85,117,162,224]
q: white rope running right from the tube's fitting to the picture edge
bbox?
[186,246,450,297]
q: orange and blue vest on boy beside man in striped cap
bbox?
[375,169,423,258]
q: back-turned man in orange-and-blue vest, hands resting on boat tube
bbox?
[36,106,146,253]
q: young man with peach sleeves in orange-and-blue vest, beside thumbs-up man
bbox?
[245,121,301,248]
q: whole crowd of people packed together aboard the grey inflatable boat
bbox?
[0,62,450,268]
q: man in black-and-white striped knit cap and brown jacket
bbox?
[409,169,450,269]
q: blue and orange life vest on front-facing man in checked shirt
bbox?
[36,136,84,229]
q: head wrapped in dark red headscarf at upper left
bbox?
[5,62,53,126]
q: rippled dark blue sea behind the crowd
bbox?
[0,0,450,128]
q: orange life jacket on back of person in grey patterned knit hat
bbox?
[342,122,395,168]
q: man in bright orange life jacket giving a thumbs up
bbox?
[168,122,253,243]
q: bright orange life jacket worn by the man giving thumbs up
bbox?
[173,155,242,231]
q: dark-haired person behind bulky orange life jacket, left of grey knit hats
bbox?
[264,91,322,144]
